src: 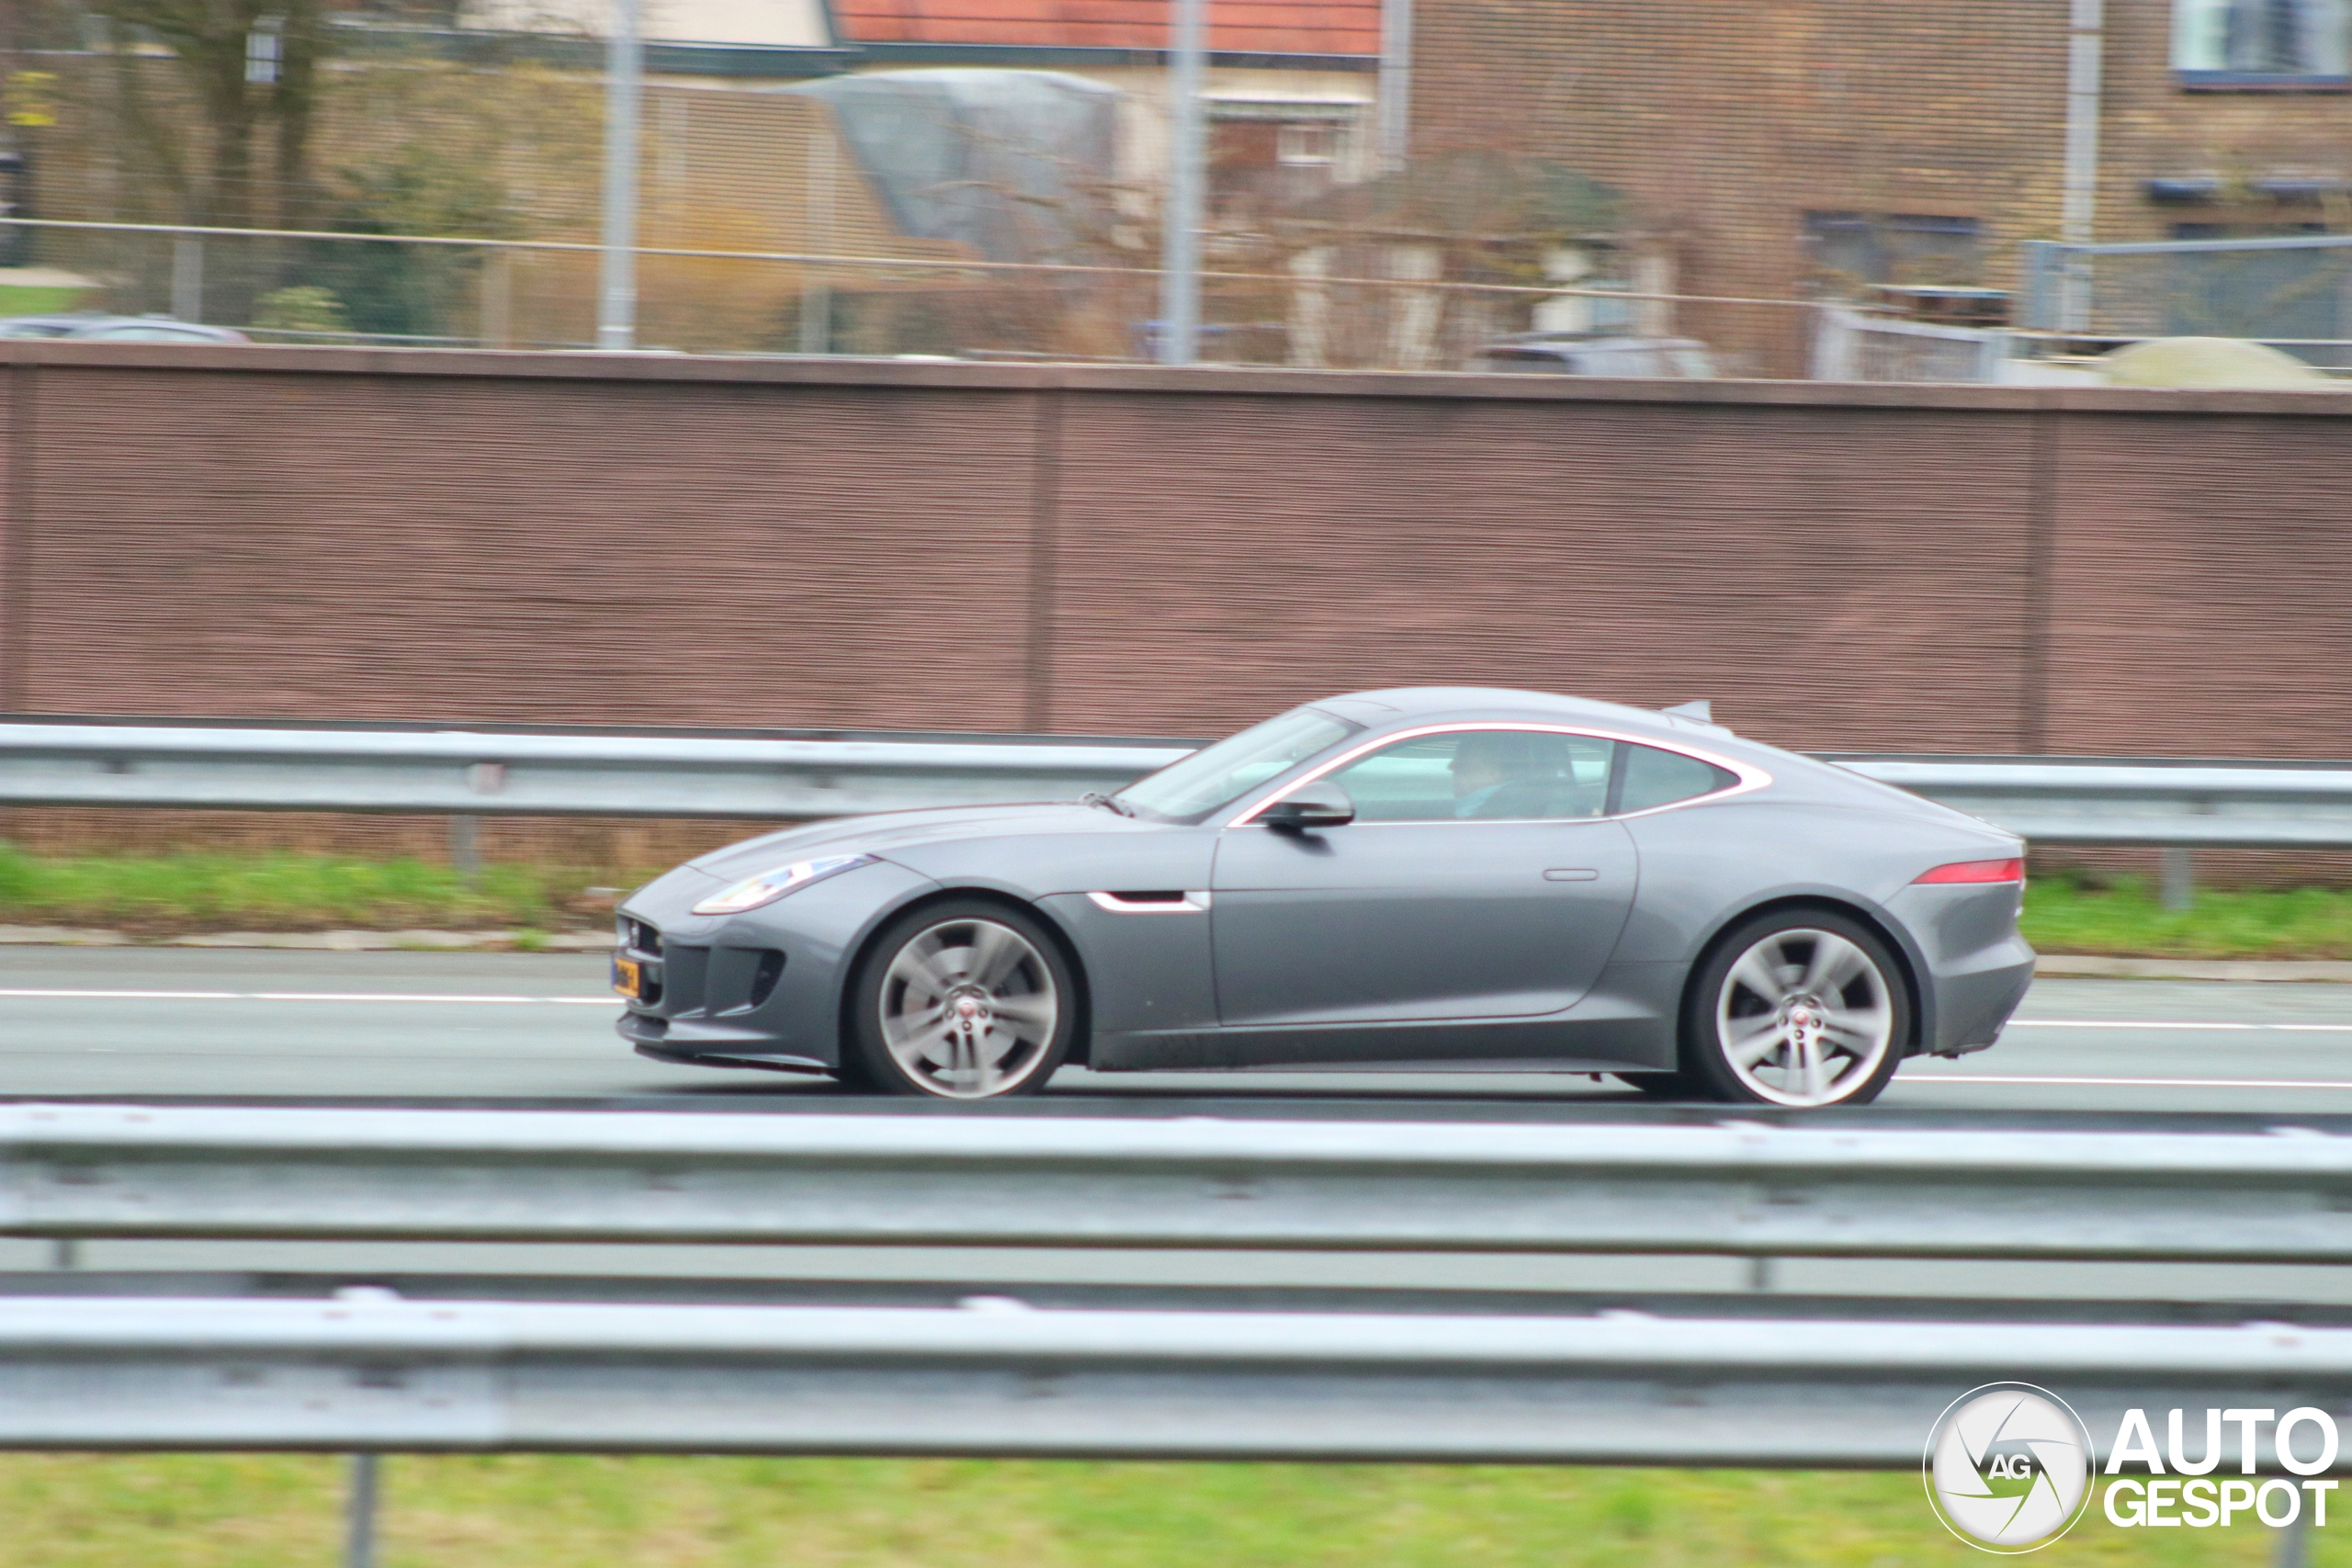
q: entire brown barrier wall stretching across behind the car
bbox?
[0,344,2352,757]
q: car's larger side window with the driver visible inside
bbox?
[1331,728,1616,823]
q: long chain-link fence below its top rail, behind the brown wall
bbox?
[0,219,1809,376]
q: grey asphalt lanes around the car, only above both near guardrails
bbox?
[0,947,2352,1114]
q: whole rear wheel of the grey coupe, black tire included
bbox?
[1681,909,1910,1110]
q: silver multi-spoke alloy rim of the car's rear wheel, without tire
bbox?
[1714,929,1895,1105]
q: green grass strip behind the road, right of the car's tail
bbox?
[2023,874,2352,959]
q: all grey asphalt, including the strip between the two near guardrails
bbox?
[0,947,2352,1303]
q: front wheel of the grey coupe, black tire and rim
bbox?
[842,898,1080,1100]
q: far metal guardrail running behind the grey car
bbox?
[0,722,2352,846]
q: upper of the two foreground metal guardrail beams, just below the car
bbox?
[0,1105,2352,1262]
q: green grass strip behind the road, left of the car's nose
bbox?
[0,844,625,933]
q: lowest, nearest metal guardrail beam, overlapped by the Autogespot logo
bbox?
[0,1291,2352,1472]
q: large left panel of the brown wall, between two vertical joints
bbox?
[17,367,1035,728]
